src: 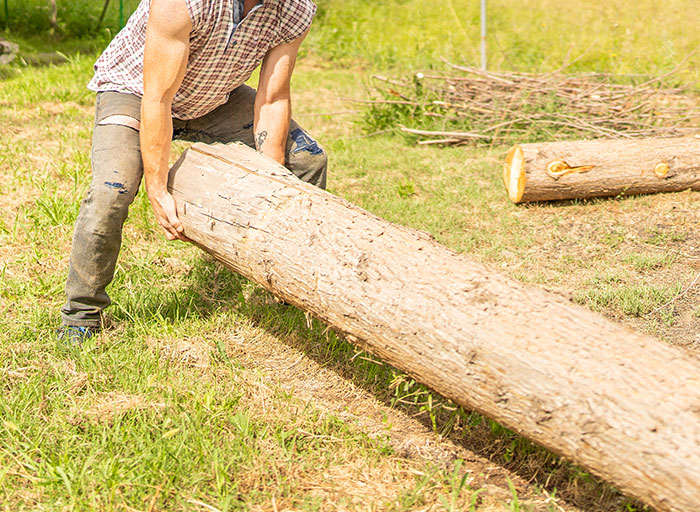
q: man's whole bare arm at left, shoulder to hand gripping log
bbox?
[140,0,192,240]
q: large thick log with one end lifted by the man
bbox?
[169,144,700,512]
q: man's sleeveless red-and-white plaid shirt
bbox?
[88,0,316,120]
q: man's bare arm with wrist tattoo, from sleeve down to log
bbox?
[253,31,308,165]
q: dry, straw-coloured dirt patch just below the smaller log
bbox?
[504,191,700,350]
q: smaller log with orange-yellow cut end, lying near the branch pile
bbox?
[503,137,700,203]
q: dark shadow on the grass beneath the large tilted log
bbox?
[138,257,647,512]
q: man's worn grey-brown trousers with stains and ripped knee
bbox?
[61,85,327,327]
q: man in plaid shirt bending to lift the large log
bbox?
[58,0,326,343]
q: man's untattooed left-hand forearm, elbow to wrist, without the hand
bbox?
[140,96,173,195]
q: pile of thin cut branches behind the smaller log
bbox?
[363,59,700,145]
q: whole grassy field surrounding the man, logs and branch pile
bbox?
[0,0,700,512]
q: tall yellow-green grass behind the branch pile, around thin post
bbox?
[309,0,698,79]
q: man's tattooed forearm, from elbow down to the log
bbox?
[253,98,291,165]
